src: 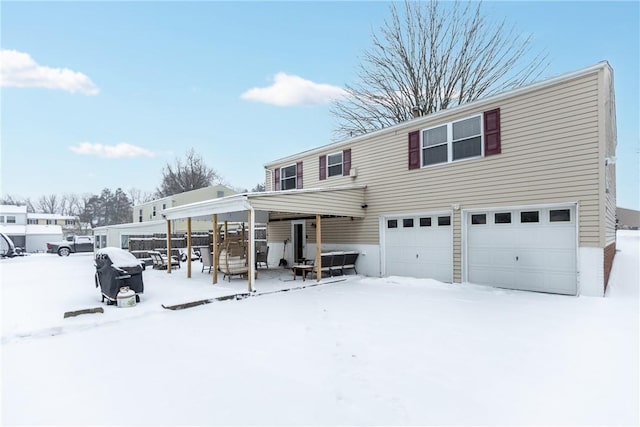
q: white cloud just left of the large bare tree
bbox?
[240,73,346,107]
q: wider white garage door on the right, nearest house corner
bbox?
[465,206,577,295]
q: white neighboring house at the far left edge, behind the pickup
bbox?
[0,205,63,252]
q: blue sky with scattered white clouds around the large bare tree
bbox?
[0,1,640,209]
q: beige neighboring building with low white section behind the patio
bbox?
[94,185,236,249]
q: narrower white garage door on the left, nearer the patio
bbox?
[384,214,453,283]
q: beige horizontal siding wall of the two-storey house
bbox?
[265,63,615,293]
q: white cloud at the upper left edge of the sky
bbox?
[0,49,100,95]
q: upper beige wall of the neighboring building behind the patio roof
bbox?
[132,185,237,222]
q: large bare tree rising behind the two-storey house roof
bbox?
[332,0,546,138]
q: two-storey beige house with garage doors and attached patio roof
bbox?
[160,62,616,296]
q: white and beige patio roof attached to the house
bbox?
[163,185,367,222]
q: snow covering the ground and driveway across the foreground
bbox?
[0,231,640,425]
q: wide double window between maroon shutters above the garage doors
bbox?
[422,115,482,166]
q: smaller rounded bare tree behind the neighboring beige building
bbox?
[156,148,222,197]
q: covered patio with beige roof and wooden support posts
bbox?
[163,185,367,292]
